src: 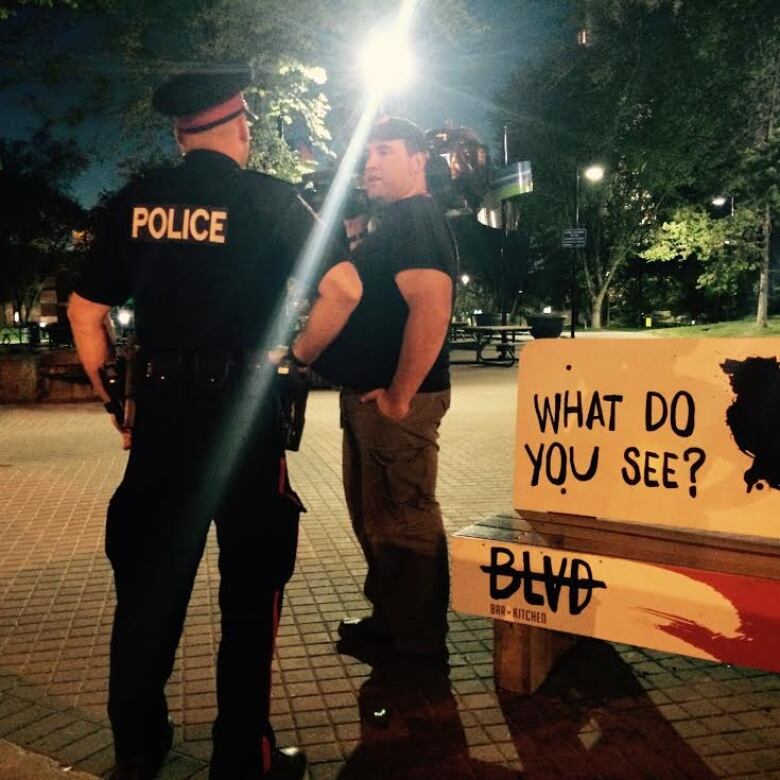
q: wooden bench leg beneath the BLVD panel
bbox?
[493,620,577,694]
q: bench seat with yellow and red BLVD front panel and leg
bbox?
[451,512,780,693]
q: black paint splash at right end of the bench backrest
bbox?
[720,357,780,493]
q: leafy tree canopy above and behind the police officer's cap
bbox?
[0,0,471,184]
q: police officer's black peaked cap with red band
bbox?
[152,67,254,133]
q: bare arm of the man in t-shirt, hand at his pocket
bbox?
[363,268,452,419]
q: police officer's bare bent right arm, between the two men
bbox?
[292,260,363,364]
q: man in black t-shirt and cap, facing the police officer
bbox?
[293,118,457,661]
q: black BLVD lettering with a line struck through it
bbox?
[479,547,607,615]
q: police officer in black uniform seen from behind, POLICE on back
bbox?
[69,69,359,780]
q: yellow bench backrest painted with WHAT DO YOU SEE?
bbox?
[514,339,780,539]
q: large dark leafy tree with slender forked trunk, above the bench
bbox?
[503,0,776,326]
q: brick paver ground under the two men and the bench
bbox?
[0,366,780,780]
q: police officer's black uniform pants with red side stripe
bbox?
[106,397,301,778]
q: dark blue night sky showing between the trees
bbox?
[0,0,561,206]
